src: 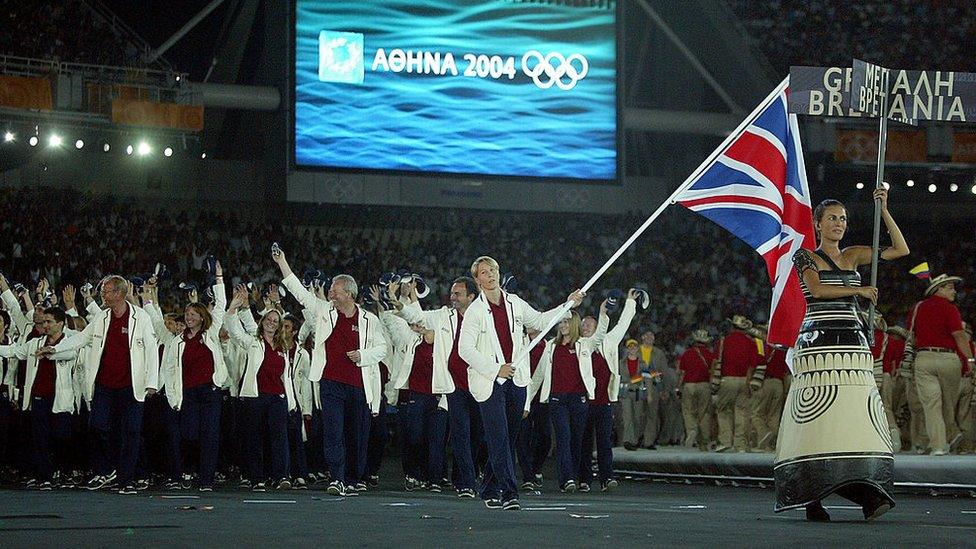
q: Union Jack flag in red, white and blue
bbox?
[674,77,816,347]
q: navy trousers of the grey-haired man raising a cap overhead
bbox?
[319,379,370,485]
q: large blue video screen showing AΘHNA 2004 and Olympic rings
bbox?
[294,0,617,180]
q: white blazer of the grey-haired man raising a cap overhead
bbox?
[281,273,388,415]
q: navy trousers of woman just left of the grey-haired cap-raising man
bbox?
[241,394,288,482]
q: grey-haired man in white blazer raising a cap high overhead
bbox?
[271,246,387,496]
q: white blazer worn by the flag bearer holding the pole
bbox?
[458,290,559,402]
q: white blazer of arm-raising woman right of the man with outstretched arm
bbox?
[156,284,227,410]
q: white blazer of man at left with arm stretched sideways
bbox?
[54,303,159,402]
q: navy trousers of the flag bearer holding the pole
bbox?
[478,379,525,501]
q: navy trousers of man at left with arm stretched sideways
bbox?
[89,384,143,486]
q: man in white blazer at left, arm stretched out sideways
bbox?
[37,275,159,494]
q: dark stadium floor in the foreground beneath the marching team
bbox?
[0,465,976,547]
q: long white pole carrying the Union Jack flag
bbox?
[498,76,790,376]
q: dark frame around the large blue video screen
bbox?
[286,0,626,186]
